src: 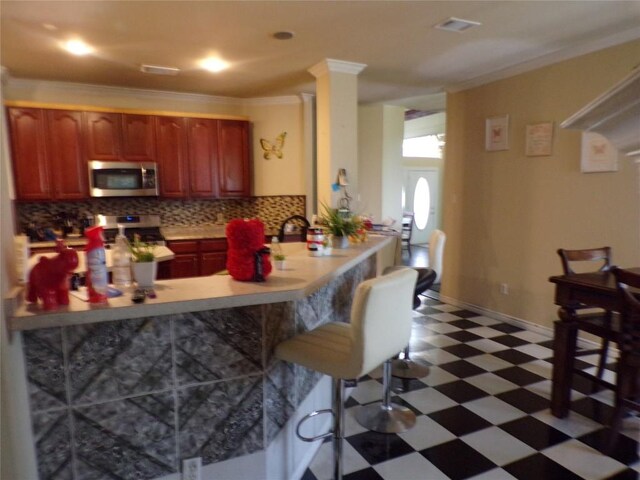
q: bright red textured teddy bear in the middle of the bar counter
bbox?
[226,219,271,282]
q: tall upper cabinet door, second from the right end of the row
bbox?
[187,118,218,198]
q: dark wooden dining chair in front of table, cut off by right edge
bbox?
[607,267,640,451]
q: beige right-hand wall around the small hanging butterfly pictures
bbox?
[442,41,640,327]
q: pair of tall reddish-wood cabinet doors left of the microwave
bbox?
[9,108,89,200]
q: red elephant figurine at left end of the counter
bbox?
[27,240,78,310]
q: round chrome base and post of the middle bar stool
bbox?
[356,360,416,433]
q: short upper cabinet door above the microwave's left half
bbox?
[85,112,122,162]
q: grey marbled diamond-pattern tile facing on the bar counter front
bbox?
[22,255,376,480]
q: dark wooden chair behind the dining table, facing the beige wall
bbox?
[558,247,613,386]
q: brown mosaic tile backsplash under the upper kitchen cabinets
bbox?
[16,195,306,231]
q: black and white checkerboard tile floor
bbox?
[302,297,640,480]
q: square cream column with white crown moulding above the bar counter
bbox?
[309,59,366,211]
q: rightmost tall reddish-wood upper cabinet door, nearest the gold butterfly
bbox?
[218,120,251,197]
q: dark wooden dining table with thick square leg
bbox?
[549,268,640,418]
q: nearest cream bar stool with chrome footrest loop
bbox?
[276,268,418,480]
